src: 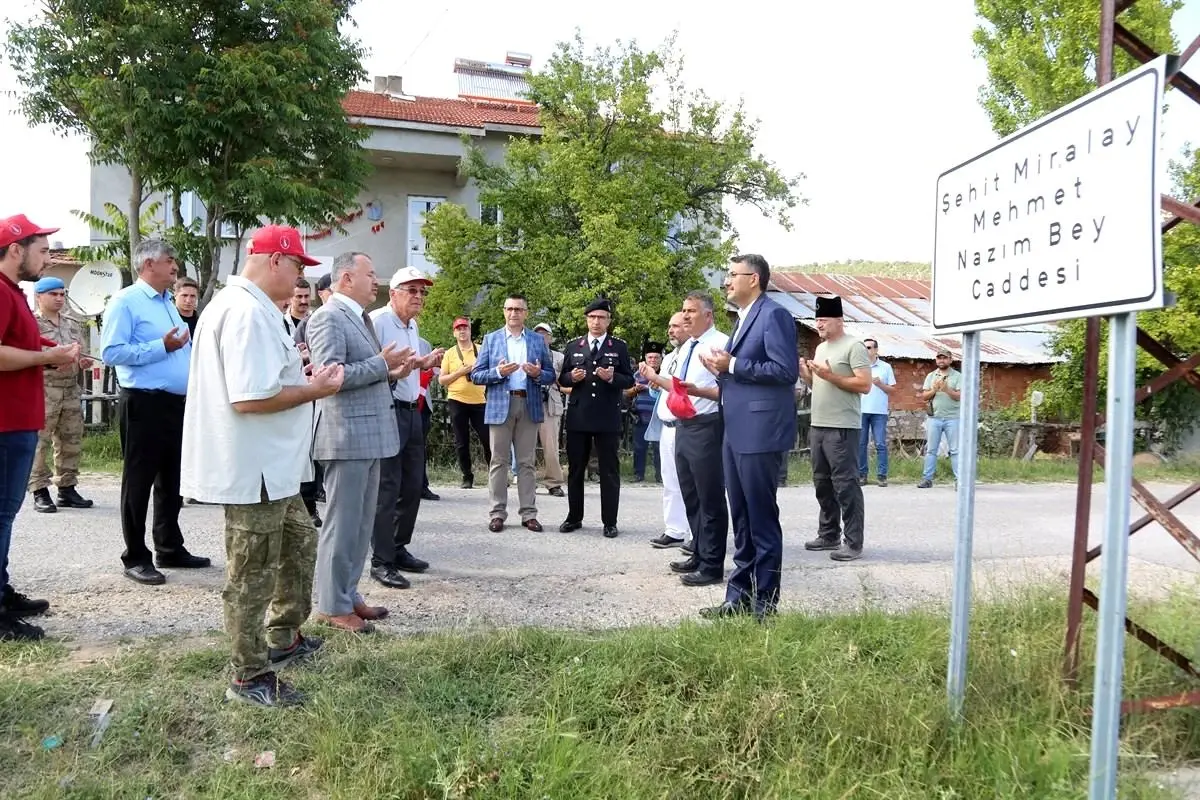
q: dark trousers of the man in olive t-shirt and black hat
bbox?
[809,428,865,551]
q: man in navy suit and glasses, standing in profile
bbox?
[700,254,799,620]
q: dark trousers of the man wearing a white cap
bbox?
[371,404,425,566]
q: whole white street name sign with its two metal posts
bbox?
[932,50,1166,767]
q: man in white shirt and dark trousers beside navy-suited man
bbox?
[641,291,730,587]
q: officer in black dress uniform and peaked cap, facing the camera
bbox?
[558,297,634,539]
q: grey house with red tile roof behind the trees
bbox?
[90,53,541,282]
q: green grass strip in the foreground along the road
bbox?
[0,591,1200,800]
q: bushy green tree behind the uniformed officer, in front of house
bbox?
[425,35,804,350]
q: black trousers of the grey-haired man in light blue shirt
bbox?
[116,389,184,567]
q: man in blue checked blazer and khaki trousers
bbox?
[470,294,557,533]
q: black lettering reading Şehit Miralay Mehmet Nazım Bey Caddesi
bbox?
[941,115,1141,300]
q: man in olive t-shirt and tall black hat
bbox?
[800,296,871,561]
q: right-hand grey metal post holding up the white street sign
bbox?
[1087,313,1138,800]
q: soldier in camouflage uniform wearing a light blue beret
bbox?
[29,277,91,513]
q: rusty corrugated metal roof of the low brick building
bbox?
[768,272,1062,365]
